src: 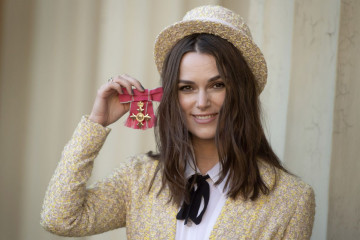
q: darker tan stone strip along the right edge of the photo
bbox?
[327,0,360,240]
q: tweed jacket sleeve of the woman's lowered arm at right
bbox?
[283,185,315,240]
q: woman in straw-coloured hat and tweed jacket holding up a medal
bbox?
[41,6,315,239]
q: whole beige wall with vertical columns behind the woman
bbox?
[0,0,360,240]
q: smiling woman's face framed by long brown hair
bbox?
[178,52,226,141]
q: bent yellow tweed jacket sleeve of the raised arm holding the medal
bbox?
[40,117,129,237]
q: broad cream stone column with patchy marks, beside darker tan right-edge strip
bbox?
[284,0,340,239]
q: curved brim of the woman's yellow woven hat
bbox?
[154,20,267,93]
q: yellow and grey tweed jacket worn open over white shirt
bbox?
[41,117,315,239]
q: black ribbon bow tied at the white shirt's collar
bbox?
[176,174,210,225]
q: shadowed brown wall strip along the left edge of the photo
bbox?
[0,0,34,239]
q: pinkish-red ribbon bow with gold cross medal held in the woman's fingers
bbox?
[119,87,163,130]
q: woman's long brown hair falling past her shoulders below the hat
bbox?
[149,34,286,205]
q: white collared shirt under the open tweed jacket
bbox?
[175,163,227,240]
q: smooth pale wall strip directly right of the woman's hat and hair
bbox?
[261,0,294,161]
